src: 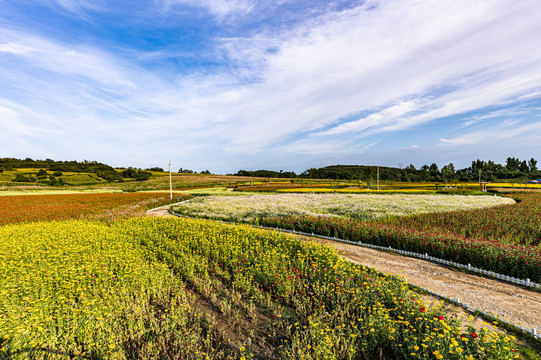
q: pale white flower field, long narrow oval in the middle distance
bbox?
[172,194,515,222]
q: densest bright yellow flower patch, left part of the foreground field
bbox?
[0,220,223,360]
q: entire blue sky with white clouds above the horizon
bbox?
[0,0,541,173]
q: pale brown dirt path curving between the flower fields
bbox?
[149,208,541,332]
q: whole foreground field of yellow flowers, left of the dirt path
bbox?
[0,217,518,360]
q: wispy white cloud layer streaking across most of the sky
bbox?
[0,0,541,170]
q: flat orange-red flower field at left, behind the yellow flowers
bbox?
[0,193,190,225]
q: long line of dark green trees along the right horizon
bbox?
[233,157,541,182]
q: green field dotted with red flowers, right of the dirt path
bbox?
[260,216,541,283]
